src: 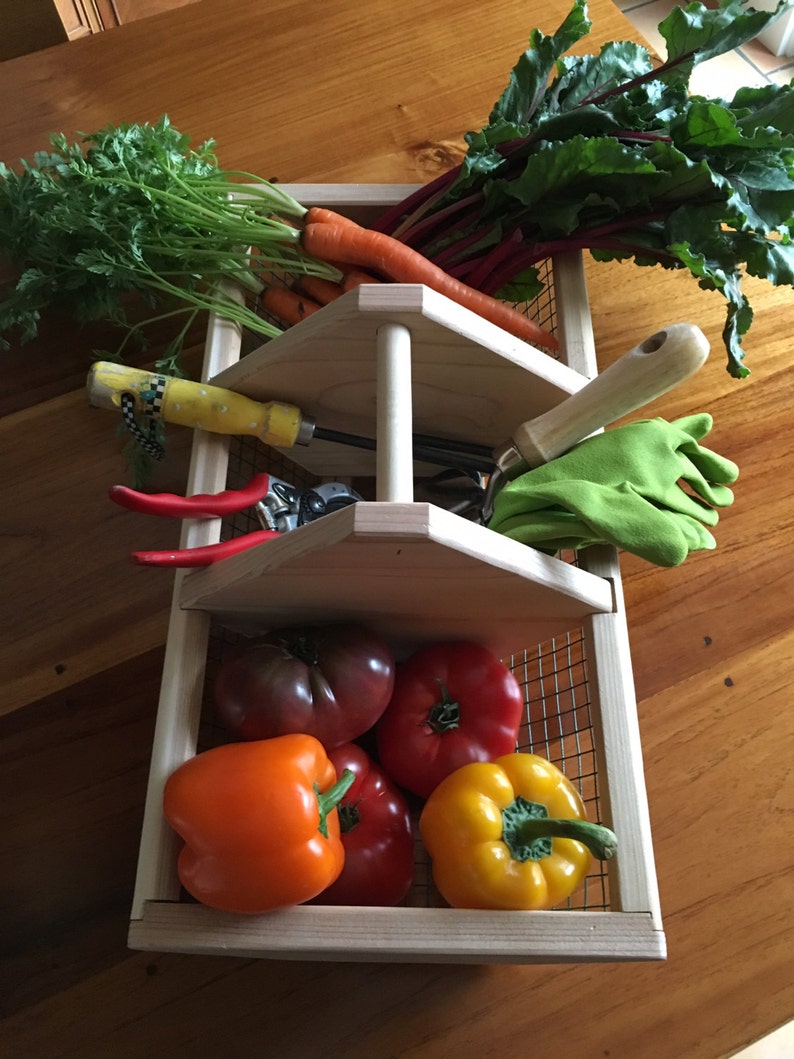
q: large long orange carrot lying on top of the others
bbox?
[303,221,559,349]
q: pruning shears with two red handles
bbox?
[109,473,361,567]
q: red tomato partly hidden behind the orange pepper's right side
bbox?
[312,743,414,905]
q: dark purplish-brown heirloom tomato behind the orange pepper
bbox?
[215,624,395,750]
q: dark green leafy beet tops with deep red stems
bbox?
[378,0,794,378]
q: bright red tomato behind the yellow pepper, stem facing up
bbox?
[376,642,524,797]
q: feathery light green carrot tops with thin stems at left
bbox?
[0,116,339,372]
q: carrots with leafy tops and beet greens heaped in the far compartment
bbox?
[0,0,794,389]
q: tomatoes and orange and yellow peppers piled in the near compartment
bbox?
[163,625,616,914]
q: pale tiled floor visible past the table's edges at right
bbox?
[615,0,794,1059]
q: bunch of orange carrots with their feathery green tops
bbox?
[0,116,556,374]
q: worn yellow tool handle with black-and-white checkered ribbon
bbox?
[86,360,304,448]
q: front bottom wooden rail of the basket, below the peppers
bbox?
[129,901,666,964]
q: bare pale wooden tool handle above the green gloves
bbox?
[497,323,708,467]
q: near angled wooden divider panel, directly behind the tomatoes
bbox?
[181,502,613,656]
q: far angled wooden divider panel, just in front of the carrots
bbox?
[213,281,584,477]
